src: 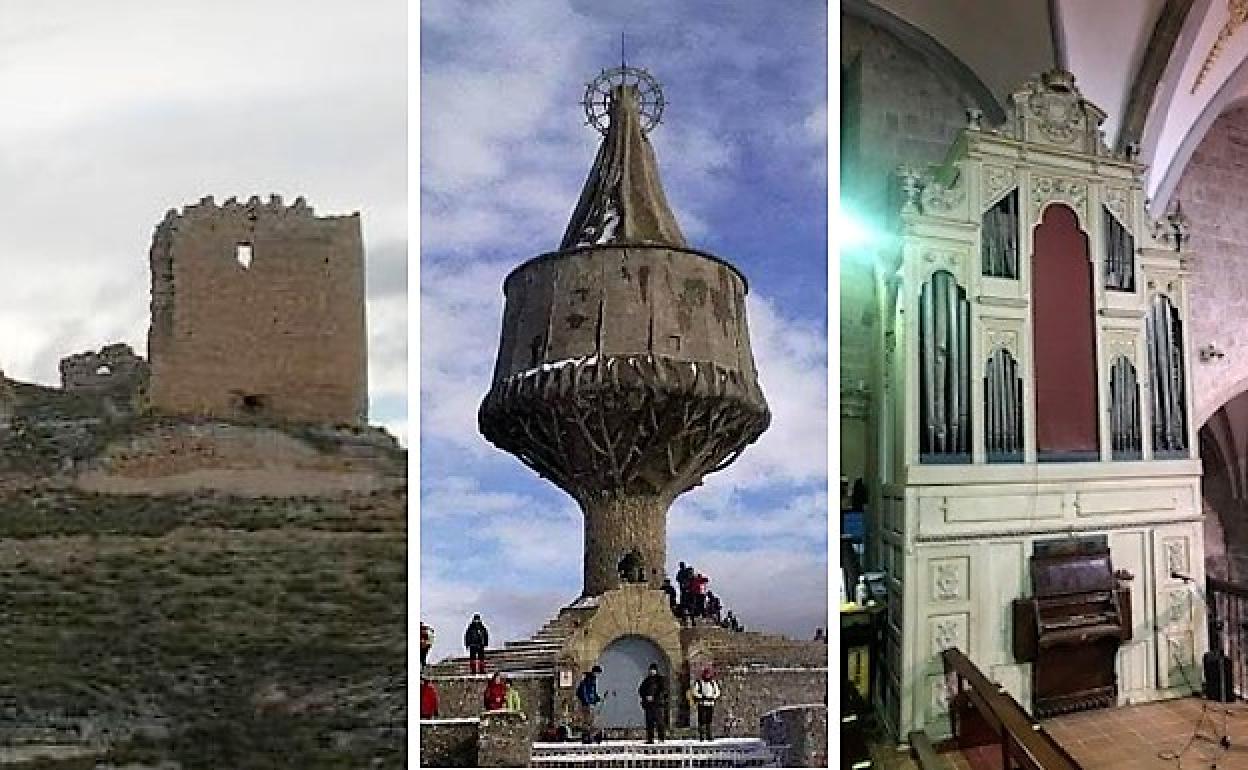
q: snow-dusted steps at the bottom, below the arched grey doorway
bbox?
[529,738,787,768]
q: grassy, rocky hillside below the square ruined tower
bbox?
[0,376,408,770]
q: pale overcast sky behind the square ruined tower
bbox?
[0,0,408,437]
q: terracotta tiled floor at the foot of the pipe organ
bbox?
[872,698,1248,770]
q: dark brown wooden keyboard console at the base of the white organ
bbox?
[1013,537,1131,718]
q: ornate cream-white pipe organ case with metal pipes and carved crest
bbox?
[867,70,1204,735]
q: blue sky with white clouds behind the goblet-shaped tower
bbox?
[419,0,827,659]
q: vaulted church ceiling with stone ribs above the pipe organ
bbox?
[858,0,1248,215]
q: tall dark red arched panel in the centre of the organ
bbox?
[1031,203,1098,453]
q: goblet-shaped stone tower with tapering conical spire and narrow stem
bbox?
[479,72,770,597]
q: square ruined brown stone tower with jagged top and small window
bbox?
[147,197,368,423]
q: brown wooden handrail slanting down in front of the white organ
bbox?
[941,648,1082,770]
